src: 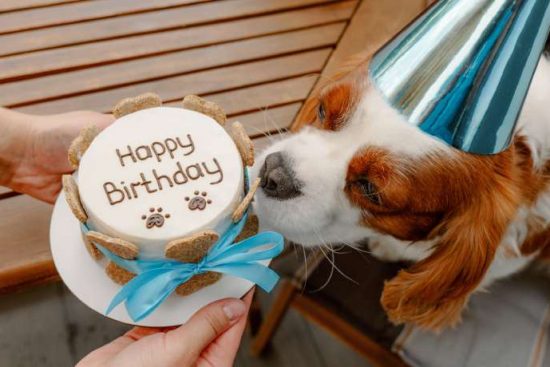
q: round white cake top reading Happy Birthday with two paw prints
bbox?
[78,107,243,247]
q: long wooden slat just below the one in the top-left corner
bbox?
[0,0,331,55]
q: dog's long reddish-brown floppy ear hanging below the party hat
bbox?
[382,158,520,331]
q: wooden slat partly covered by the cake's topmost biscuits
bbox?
[18,49,331,114]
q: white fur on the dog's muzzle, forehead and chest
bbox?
[253,58,550,286]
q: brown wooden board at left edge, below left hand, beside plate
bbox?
[0,195,55,289]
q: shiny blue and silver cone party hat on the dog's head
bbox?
[369,0,550,154]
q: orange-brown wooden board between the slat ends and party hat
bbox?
[292,0,427,130]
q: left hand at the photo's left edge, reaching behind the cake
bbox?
[0,108,114,203]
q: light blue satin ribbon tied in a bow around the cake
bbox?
[83,213,284,322]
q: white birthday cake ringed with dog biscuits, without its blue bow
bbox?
[63,94,257,295]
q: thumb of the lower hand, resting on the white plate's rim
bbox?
[166,299,247,363]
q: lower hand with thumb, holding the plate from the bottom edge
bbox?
[77,291,253,367]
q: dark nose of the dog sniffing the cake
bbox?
[260,152,301,200]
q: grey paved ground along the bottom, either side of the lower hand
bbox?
[0,255,374,367]
